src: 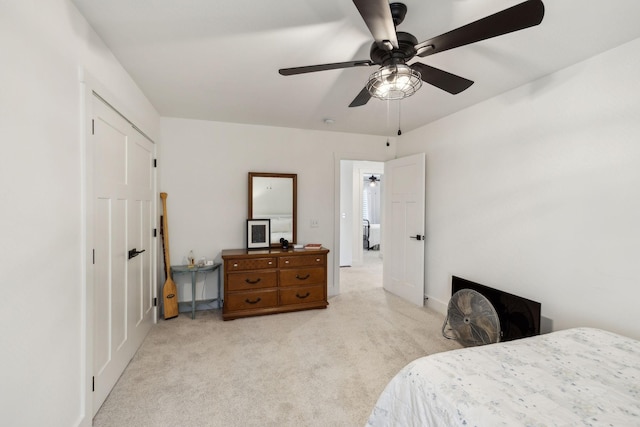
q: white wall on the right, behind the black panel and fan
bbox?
[398,39,640,338]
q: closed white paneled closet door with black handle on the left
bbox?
[89,96,155,415]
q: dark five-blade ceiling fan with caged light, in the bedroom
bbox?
[278,0,544,107]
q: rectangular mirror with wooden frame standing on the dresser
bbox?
[248,172,298,246]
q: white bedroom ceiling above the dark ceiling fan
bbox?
[73,0,640,136]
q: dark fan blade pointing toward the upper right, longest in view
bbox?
[415,0,544,57]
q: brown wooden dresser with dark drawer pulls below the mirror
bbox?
[222,248,329,320]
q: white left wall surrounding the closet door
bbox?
[0,0,159,427]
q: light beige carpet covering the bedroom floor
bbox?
[94,252,459,427]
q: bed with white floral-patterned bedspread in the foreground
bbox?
[367,328,640,427]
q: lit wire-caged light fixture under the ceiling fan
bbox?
[367,64,422,100]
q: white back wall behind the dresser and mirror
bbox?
[160,118,395,300]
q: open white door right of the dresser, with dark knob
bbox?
[382,153,425,306]
